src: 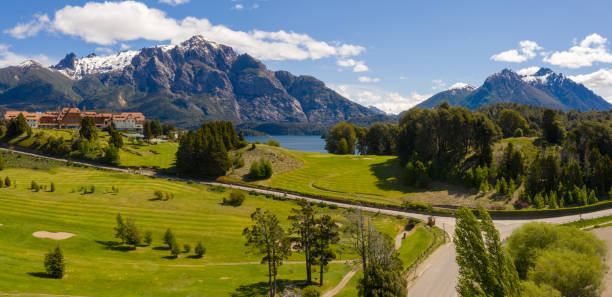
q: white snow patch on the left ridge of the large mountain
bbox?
[57,51,139,80]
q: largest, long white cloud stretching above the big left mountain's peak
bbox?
[11,0,367,61]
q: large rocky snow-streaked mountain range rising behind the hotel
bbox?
[0,35,378,127]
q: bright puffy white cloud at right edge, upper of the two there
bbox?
[544,33,612,69]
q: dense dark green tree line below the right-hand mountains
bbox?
[326,102,612,208]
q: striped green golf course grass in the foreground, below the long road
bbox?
[0,166,406,296]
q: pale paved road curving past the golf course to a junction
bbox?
[0,148,612,297]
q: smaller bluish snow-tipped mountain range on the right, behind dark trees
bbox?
[417,68,612,111]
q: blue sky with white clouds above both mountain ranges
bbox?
[0,0,612,113]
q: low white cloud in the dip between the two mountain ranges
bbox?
[330,85,431,114]
